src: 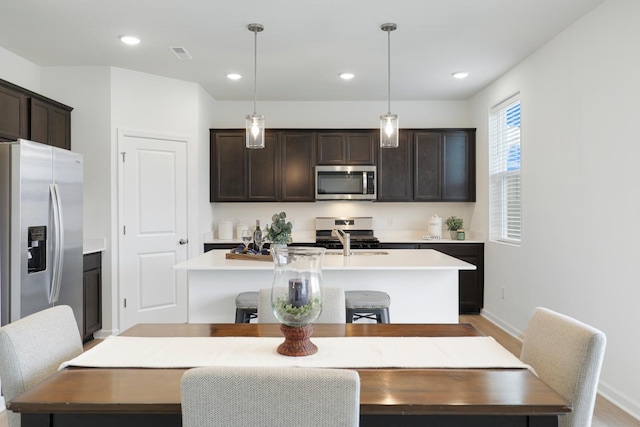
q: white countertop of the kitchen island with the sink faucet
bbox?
[174,249,476,271]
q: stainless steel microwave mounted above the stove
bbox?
[316,166,377,200]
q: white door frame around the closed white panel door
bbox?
[117,128,191,335]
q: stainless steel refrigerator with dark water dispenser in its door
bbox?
[0,139,84,331]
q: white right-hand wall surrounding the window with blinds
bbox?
[471,0,640,418]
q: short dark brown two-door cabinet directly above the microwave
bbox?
[317,130,378,165]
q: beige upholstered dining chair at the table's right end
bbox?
[520,307,606,427]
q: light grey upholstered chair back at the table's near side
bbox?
[182,366,360,427]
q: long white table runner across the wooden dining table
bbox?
[60,336,529,369]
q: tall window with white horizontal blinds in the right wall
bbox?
[489,95,522,244]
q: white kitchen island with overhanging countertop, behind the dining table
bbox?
[174,249,476,323]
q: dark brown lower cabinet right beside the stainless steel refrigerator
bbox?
[82,252,102,342]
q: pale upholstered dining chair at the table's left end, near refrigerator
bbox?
[0,305,83,427]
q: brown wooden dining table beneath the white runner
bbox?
[8,323,571,427]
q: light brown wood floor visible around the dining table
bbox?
[0,315,640,427]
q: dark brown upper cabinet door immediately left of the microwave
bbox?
[279,131,317,202]
